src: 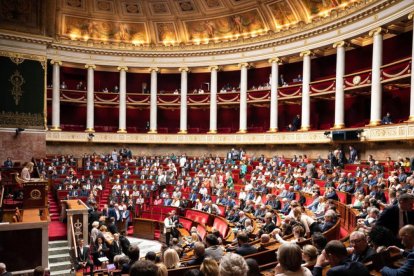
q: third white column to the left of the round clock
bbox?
[268,57,279,132]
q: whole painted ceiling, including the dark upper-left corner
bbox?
[0,0,370,47]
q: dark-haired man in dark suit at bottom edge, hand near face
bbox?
[312,240,370,276]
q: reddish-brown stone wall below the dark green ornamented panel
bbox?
[0,129,46,165]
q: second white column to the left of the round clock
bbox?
[300,51,312,131]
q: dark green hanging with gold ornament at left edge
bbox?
[0,54,46,128]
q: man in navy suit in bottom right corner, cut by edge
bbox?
[381,225,414,276]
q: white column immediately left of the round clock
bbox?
[333,41,345,129]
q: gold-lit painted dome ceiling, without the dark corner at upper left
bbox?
[57,0,355,45]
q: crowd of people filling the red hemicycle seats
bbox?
[3,147,414,275]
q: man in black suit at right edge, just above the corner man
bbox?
[376,193,414,236]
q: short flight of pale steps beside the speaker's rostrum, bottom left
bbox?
[49,241,73,276]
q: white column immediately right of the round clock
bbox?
[369,27,384,126]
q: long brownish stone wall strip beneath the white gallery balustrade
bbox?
[47,142,414,160]
